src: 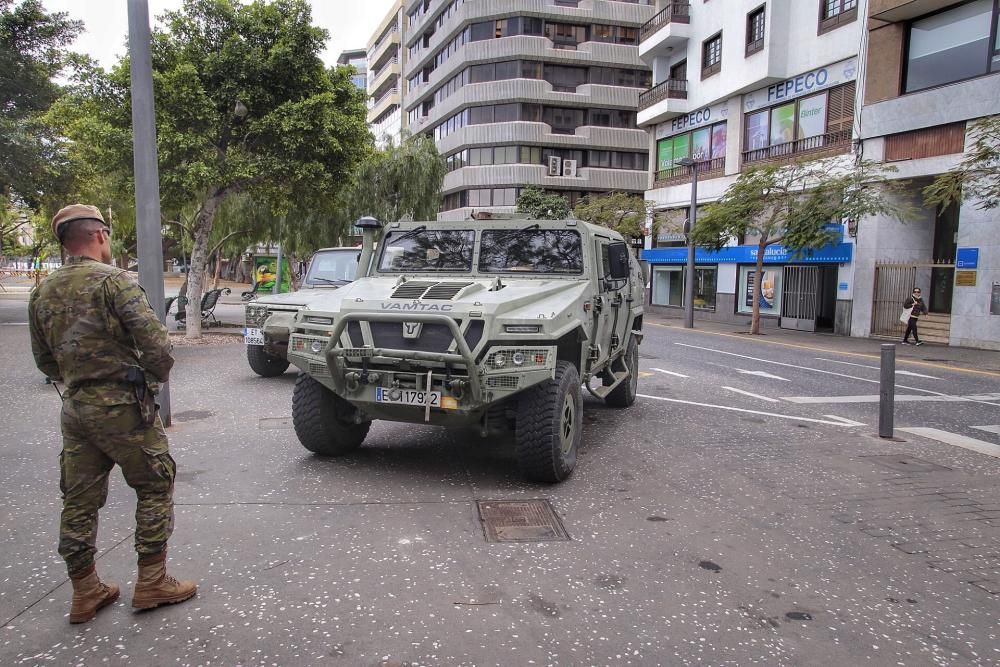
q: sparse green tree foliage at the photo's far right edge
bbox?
[924,116,1000,210]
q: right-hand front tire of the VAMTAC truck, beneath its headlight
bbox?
[515,361,583,483]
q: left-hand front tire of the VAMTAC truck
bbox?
[292,373,372,456]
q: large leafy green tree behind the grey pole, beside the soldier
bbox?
[56,0,371,338]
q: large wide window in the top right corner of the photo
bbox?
[904,0,1000,93]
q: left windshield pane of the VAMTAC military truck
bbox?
[378,227,476,272]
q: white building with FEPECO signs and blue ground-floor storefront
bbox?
[638,0,864,333]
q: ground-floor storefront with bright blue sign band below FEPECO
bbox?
[642,241,854,331]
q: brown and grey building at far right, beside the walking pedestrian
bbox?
[851,0,1000,349]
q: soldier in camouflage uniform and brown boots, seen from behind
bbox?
[28,204,197,623]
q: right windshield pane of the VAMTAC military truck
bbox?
[479,229,583,273]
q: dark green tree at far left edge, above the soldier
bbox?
[0,0,82,207]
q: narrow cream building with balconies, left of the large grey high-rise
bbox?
[368,0,406,145]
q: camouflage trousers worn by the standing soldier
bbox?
[59,399,176,575]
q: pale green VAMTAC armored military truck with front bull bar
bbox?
[288,219,644,482]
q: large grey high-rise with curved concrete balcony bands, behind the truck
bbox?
[403,0,654,220]
